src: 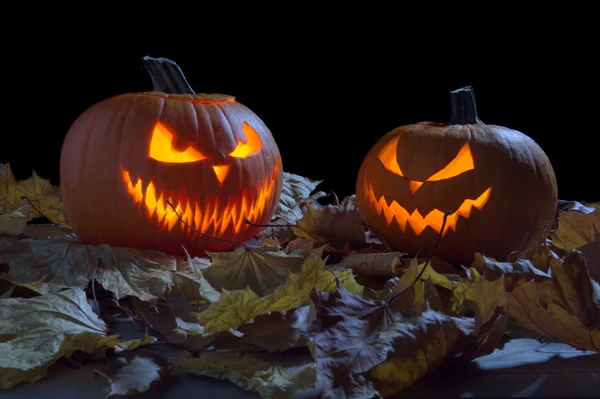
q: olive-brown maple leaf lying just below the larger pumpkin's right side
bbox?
[204,247,304,297]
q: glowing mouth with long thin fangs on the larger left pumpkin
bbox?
[121,167,279,236]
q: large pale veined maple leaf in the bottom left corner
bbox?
[0,288,118,389]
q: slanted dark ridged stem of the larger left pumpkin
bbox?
[142,55,196,94]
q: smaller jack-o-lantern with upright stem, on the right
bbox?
[356,87,557,264]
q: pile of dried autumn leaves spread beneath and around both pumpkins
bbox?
[0,165,600,398]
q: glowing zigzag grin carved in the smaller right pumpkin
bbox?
[363,182,492,236]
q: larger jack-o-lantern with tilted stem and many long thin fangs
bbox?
[60,57,283,256]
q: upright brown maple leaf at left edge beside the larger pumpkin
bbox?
[0,163,69,228]
